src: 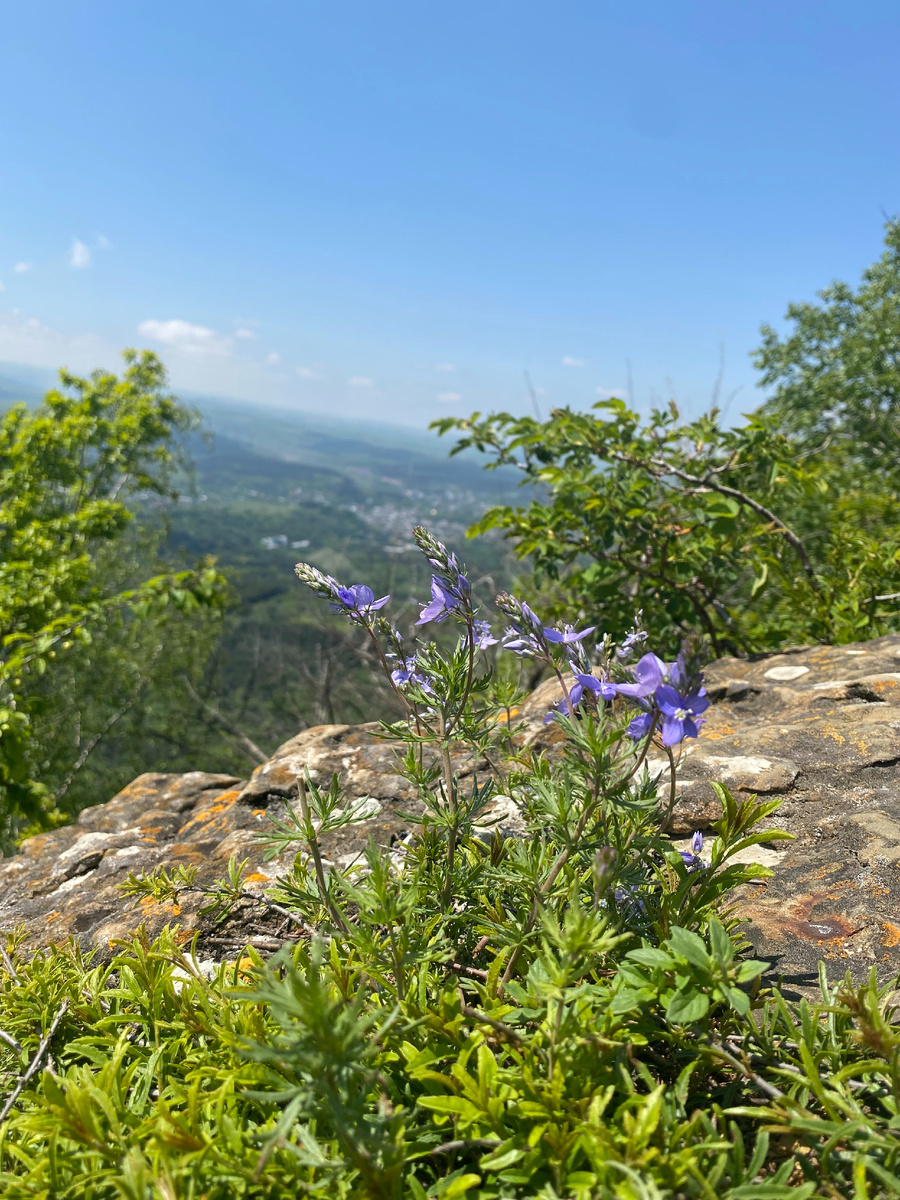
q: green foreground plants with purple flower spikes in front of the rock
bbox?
[0,529,900,1200]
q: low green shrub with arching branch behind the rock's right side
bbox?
[438,401,900,655]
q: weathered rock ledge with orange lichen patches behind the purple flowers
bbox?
[0,636,900,990]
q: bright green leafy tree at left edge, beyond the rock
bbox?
[0,350,224,838]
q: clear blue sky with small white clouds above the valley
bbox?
[0,0,900,425]
